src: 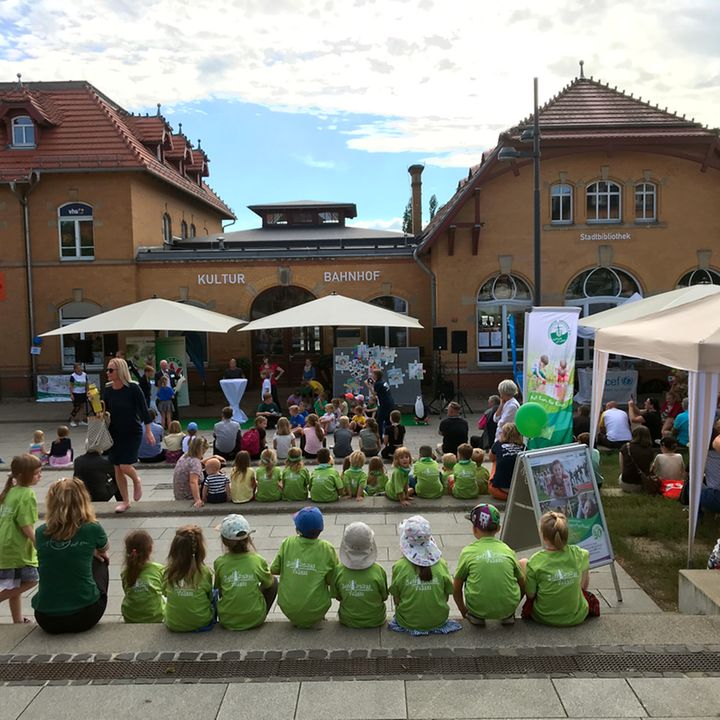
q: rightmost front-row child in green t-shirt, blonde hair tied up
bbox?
[520,512,600,626]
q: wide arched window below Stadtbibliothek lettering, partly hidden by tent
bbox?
[565,267,640,362]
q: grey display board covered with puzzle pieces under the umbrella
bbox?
[333,344,426,405]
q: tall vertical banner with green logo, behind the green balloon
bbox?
[523,307,580,450]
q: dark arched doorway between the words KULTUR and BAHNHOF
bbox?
[250,285,322,385]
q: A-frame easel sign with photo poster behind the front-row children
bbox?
[501,444,615,568]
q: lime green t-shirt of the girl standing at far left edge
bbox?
[0,485,38,570]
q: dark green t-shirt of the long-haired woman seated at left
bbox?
[32,523,107,615]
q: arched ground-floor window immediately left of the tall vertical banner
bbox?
[477,274,532,365]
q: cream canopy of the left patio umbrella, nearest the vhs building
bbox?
[41,298,246,337]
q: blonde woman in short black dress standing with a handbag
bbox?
[103,358,155,513]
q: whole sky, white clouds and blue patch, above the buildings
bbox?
[0,0,720,230]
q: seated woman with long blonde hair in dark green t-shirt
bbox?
[32,478,110,635]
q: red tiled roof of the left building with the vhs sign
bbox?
[0,82,235,218]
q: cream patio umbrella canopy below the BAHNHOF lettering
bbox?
[239,294,422,332]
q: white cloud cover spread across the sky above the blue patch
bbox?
[0,0,720,160]
